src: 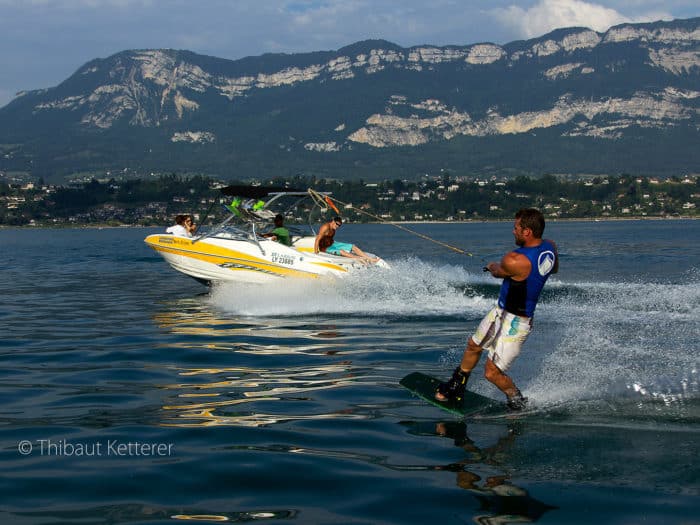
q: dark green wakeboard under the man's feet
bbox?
[399,372,508,416]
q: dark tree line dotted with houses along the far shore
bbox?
[0,174,700,226]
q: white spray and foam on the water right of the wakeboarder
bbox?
[527,280,700,415]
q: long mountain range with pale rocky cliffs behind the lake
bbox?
[0,18,700,180]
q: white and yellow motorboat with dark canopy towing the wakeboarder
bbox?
[144,186,387,284]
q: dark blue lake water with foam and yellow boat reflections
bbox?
[0,220,700,524]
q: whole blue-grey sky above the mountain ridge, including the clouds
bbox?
[0,0,700,107]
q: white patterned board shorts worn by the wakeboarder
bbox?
[472,306,532,372]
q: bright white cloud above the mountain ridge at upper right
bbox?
[491,0,672,38]
